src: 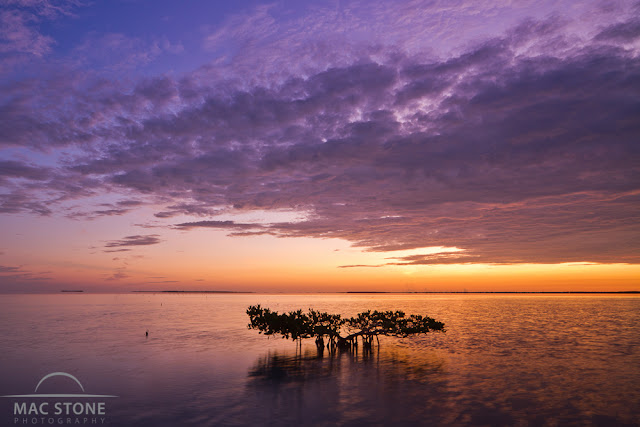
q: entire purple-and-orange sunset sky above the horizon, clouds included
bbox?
[0,0,640,292]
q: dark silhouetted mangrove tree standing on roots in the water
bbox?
[247,305,445,350]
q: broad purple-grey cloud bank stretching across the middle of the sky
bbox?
[0,8,640,265]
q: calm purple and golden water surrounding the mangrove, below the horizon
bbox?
[0,294,640,426]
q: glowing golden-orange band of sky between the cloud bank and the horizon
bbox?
[2,201,640,292]
